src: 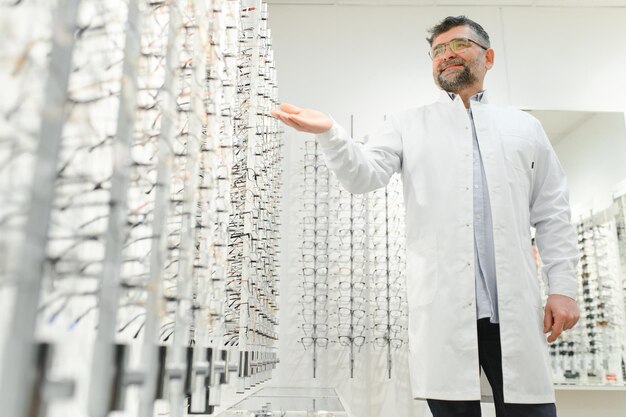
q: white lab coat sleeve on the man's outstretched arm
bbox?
[316,116,402,194]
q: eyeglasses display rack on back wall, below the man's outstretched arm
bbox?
[299,115,407,378]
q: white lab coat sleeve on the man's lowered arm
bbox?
[530,120,579,300]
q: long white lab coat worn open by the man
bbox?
[317,93,578,403]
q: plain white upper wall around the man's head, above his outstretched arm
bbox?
[270,5,626,135]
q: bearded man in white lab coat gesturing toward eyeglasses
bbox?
[273,16,579,417]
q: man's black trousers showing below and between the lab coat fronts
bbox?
[428,318,556,417]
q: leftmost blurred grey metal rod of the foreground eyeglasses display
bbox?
[0,0,80,417]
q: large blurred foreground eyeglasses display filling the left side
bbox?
[0,0,283,417]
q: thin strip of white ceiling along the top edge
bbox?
[267,0,626,7]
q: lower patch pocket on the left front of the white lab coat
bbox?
[406,237,438,306]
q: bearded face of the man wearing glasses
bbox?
[433,26,493,94]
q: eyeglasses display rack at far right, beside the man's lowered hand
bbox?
[533,193,626,386]
